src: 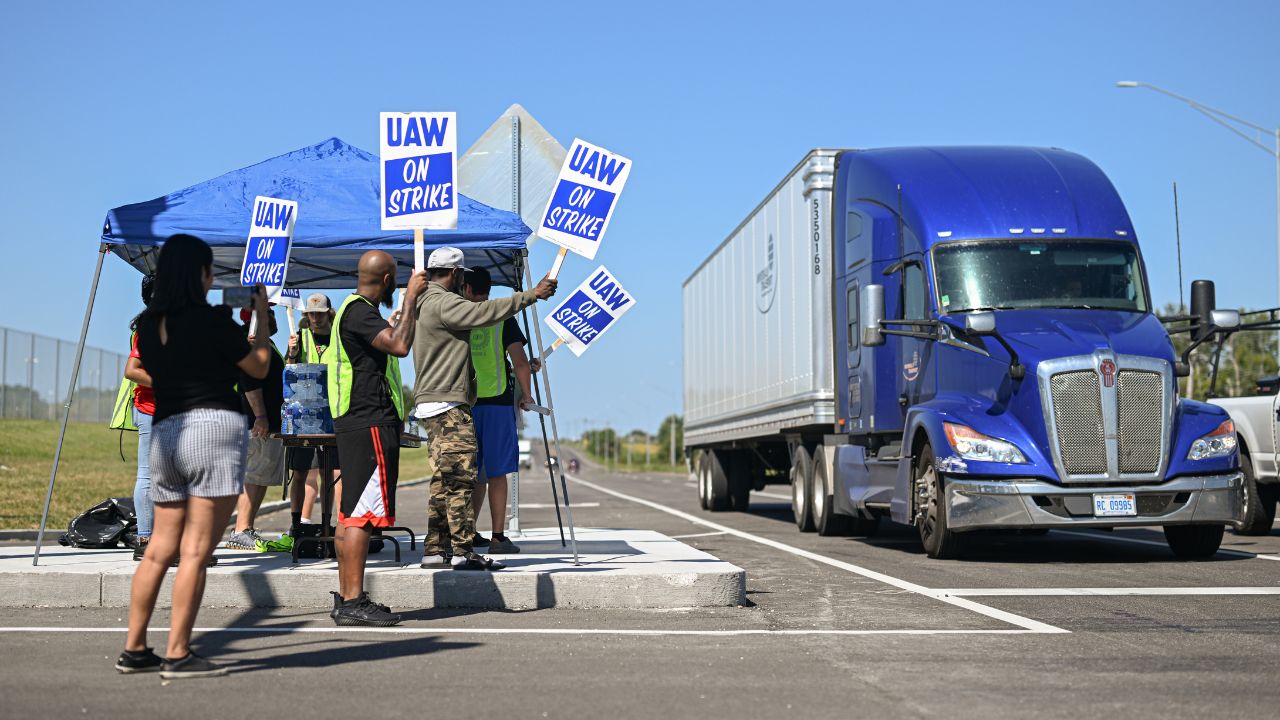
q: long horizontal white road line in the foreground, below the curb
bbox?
[0,625,1039,637]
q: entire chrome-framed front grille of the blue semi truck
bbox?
[1039,354,1174,482]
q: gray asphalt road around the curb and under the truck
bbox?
[0,443,1280,720]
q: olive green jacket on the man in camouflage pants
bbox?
[413,282,538,405]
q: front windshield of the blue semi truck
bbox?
[933,240,1147,313]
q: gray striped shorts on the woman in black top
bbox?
[151,409,248,502]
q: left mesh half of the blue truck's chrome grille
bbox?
[1050,370,1107,475]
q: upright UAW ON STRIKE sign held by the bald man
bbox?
[378,113,458,231]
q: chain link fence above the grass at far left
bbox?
[0,328,128,423]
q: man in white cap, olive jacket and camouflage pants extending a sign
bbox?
[413,247,556,570]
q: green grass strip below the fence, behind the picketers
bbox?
[0,419,431,529]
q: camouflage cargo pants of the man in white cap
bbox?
[422,405,476,555]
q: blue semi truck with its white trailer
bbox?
[684,147,1242,559]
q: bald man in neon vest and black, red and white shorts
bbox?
[325,250,426,626]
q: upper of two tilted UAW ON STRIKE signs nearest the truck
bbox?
[538,138,631,260]
